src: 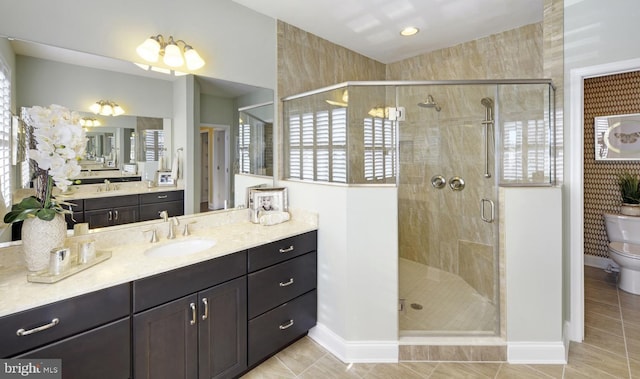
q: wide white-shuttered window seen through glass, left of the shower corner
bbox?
[289,108,347,183]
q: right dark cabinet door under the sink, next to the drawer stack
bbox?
[198,277,247,379]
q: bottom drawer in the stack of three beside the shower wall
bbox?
[249,290,317,366]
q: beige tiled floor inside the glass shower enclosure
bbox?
[399,258,496,335]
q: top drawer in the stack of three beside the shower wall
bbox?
[247,230,318,272]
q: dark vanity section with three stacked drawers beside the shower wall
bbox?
[247,231,317,367]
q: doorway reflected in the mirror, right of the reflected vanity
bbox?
[200,124,231,212]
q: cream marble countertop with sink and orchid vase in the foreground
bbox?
[0,209,318,317]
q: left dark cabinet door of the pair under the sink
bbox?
[133,295,198,379]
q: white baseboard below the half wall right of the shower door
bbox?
[507,341,569,364]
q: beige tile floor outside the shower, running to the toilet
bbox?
[243,267,640,379]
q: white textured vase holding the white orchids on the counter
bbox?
[22,214,67,271]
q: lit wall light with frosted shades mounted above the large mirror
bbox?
[136,34,204,70]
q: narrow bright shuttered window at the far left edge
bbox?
[0,60,12,212]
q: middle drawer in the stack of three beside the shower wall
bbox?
[248,251,317,319]
